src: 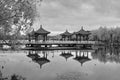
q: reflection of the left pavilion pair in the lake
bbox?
[27,51,50,68]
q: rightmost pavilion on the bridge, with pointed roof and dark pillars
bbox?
[74,27,91,41]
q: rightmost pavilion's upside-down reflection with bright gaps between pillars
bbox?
[74,51,91,66]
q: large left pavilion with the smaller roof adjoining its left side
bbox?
[29,25,50,41]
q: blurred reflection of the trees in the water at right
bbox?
[91,46,120,63]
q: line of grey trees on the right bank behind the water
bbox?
[90,27,120,43]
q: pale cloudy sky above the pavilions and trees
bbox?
[34,0,120,34]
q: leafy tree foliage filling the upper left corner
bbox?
[0,0,42,39]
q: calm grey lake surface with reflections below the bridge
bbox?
[0,49,120,80]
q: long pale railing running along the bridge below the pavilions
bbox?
[0,40,98,44]
